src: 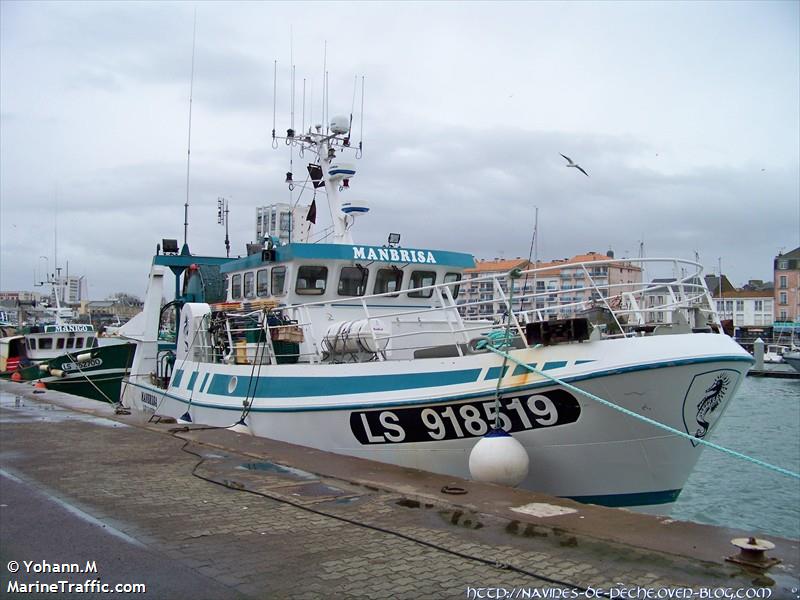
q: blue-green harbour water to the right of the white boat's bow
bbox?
[671,377,800,539]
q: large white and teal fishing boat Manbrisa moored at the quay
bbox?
[124,115,752,510]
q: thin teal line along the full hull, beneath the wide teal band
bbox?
[129,356,753,413]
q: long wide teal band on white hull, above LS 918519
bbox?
[208,369,481,398]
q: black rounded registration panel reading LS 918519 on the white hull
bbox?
[350,390,581,444]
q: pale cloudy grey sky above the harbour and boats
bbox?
[0,0,800,299]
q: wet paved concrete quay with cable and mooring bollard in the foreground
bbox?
[0,382,800,599]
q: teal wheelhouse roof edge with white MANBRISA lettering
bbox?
[222,244,475,273]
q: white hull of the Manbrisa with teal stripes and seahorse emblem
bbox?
[126,334,751,506]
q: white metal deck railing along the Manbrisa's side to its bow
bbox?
[195,258,721,363]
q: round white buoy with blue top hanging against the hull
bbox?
[469,429,530,487]
